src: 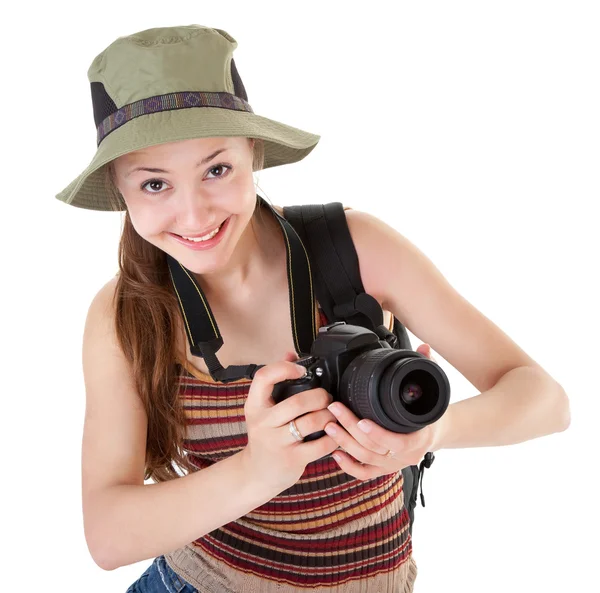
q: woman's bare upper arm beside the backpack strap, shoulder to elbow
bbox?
[346,210,541,391]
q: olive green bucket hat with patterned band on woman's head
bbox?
[56,25,321,210]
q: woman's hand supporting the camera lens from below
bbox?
[325,344,439,480]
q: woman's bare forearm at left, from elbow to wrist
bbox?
[85,451,278,570]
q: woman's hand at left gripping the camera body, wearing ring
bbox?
[241,353,338,496]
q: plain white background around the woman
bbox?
[0,0,600,593]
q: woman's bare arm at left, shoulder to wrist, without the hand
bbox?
[82,280,278,570]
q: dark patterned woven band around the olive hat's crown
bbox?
[96,91,254,146]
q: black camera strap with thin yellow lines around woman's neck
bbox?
[167,194,317,383]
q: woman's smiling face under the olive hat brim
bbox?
[114,137,256,274]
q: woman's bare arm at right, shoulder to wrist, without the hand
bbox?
[346,210,570,449]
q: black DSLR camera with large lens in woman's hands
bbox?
[273,321,450,441]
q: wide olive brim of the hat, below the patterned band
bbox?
[56,107,321,210]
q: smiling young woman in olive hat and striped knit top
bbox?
[57,25,569,593]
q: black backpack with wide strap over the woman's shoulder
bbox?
[283,202,435,535]
